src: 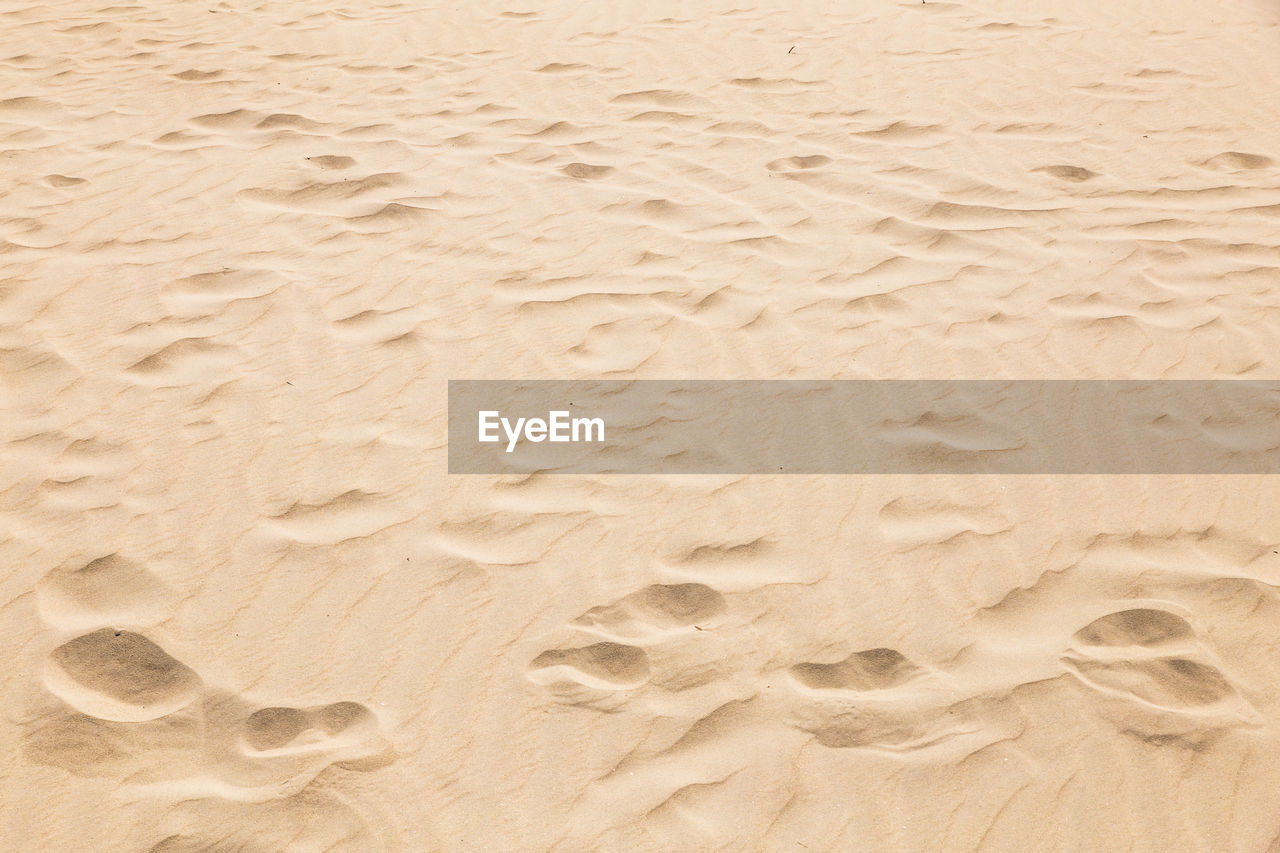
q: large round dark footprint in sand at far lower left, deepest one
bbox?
[45,628,202,722]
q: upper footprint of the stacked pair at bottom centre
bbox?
[570,584,724,639]
